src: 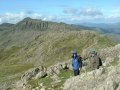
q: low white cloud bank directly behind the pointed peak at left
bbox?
[0,12,57,23]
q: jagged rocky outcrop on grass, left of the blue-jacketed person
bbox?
[14,62,70,90]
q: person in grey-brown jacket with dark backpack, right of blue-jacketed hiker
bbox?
[90,50,102,70]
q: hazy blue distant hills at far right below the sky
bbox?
[74,23,120,42]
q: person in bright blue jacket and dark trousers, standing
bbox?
[72,50,82,76]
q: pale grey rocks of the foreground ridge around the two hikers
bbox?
[7,44,120,90]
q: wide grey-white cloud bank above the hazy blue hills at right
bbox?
[64,8,120,23]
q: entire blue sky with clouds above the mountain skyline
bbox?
[0,0,120,24]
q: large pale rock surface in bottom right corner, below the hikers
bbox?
[64,62,120,90]
